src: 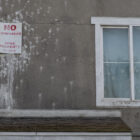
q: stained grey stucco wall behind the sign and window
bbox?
[0,0,140,139]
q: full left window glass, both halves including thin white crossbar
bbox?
[103,28,130,98]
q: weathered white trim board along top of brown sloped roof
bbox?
[0,110,121,117]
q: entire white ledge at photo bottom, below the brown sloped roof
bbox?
[0,132,132,140]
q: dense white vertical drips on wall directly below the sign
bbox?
[0,55,15,109]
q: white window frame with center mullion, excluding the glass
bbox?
[91,17,140,107]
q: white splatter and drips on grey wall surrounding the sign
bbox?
[0,0,40,109]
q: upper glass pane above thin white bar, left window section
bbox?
[103,28,129,62]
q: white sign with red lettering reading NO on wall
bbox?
[0,23,22,54]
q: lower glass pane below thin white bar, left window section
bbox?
[104,63,130,98]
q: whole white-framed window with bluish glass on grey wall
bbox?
[91,17,140,107]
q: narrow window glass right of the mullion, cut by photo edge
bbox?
[133,27,140,100]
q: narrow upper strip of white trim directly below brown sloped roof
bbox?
[0,132,132,136]
